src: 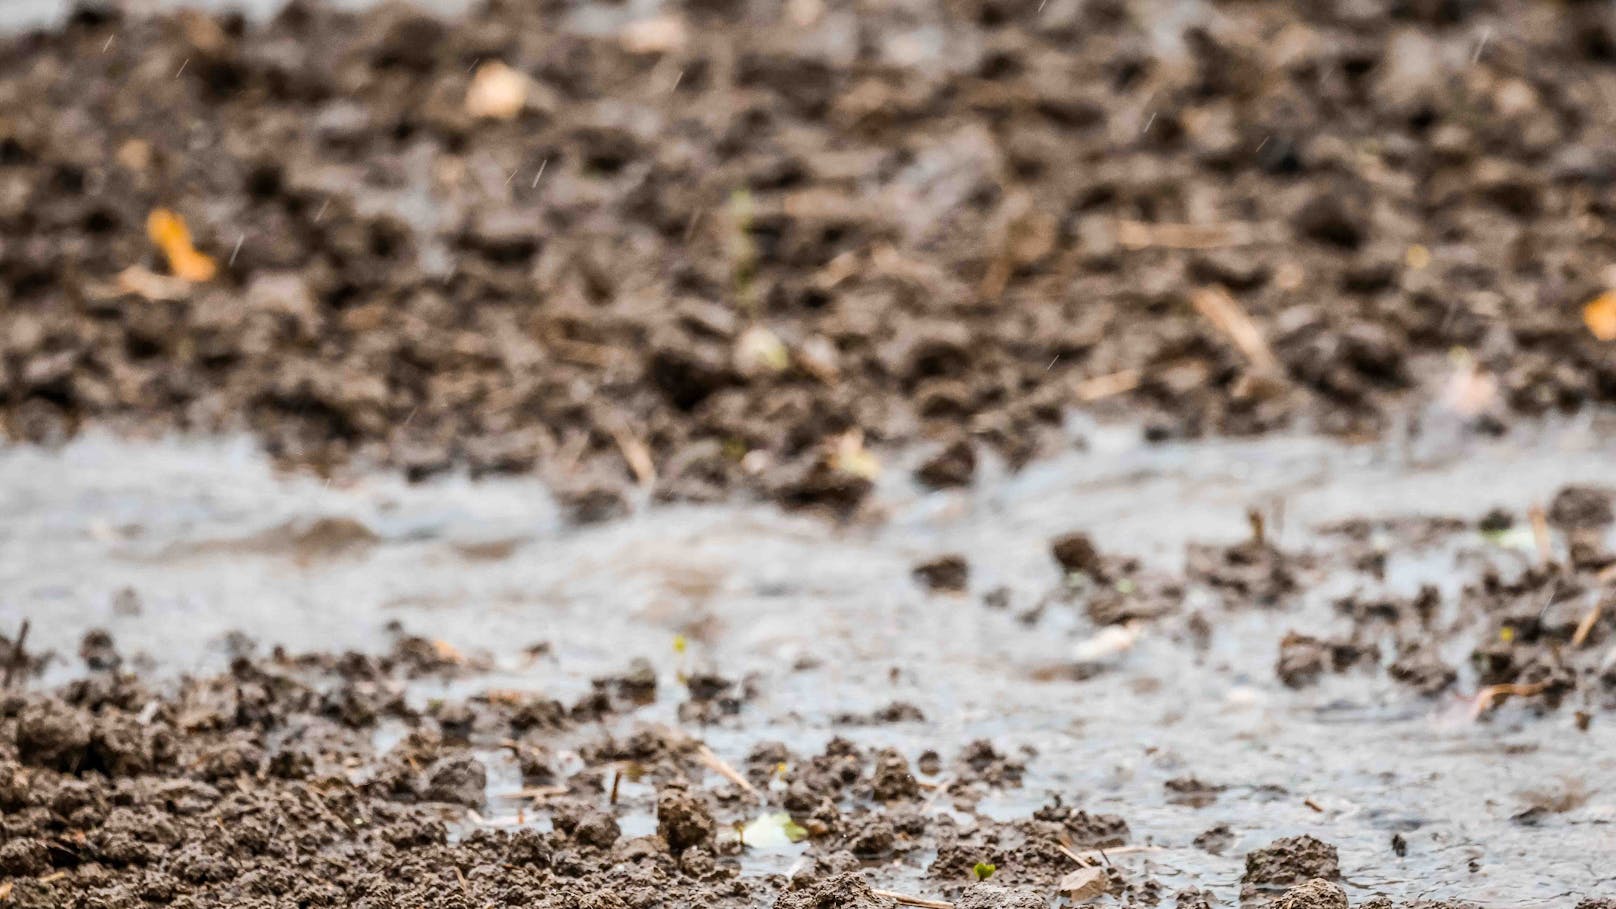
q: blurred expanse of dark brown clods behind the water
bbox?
[9,0,1616,519]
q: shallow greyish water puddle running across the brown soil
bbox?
[0,422,1616,906]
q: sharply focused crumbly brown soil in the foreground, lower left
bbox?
[0,634,1486,909]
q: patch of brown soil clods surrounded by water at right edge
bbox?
[1111,485,1616,714]
